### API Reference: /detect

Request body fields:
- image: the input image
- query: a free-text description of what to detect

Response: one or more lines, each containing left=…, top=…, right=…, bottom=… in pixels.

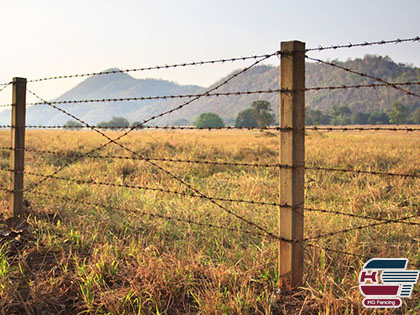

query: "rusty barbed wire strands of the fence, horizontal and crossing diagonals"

left=0, top=37, right=420, bottom=288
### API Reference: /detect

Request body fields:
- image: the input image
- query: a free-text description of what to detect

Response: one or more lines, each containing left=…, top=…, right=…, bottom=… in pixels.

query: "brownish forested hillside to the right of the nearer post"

left=306, top=55, right=420, bottom=112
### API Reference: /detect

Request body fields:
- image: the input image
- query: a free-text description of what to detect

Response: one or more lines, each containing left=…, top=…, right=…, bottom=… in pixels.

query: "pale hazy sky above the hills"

left=0, top=0, right=420, bottom=103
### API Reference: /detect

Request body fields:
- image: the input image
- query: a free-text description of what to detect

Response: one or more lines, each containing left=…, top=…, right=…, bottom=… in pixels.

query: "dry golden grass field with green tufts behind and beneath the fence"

left=0, top=130, right=420, bottom=314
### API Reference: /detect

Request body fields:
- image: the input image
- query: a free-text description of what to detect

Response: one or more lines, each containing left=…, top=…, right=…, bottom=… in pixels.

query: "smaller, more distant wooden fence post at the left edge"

left=9, top=78, right=26, bottom=217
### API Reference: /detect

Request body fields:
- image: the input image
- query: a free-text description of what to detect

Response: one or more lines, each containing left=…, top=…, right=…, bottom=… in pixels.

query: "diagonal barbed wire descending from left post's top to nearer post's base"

left=24, top=89, right=290, bottom=241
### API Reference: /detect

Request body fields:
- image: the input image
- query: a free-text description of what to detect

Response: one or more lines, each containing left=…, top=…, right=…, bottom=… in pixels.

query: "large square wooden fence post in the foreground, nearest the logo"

left=279, top=41, right=305, bottom=289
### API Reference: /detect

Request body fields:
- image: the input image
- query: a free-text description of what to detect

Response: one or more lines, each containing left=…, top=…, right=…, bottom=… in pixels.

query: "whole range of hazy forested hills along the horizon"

left=0, top=55, right=420, bottom=124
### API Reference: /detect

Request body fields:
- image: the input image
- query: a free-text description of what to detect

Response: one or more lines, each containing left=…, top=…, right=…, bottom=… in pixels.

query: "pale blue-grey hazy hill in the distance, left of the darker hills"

left=0, top=69, right=201, bottom=125
